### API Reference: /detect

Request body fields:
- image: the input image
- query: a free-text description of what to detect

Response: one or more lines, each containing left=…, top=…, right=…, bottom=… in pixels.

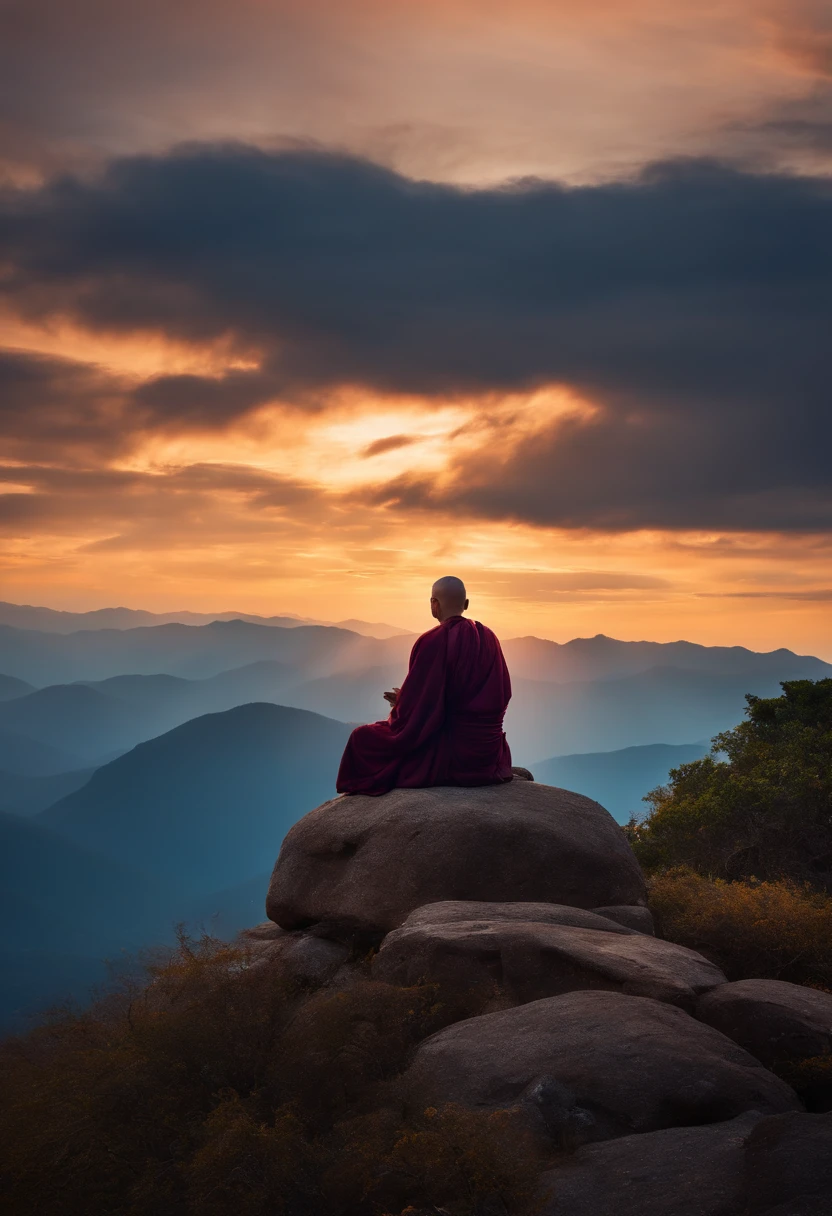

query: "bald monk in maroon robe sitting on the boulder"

left=336, top=576, right=512, bottom=794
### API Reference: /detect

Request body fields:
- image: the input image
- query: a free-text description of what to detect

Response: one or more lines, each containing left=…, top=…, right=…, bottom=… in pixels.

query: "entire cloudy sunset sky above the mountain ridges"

left=0, top=0, right=832, bottom=659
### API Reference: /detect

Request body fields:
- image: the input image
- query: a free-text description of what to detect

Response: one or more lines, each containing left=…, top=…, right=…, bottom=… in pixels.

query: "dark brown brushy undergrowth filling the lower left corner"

left=0, top=938, right=540, bottom=1216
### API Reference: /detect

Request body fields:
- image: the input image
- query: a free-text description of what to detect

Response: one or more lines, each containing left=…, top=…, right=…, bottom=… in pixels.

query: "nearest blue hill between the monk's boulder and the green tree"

left=532, top=743, right=710, bottom=823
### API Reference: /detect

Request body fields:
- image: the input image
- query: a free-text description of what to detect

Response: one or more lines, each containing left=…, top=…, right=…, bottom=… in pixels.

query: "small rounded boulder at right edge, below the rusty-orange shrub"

left=696, top=980, right=832, bottom=1065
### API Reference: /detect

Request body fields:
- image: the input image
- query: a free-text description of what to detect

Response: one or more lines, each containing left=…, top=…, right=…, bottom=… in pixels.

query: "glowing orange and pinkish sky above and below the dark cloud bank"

left=0, top=0, right=832, bottom=659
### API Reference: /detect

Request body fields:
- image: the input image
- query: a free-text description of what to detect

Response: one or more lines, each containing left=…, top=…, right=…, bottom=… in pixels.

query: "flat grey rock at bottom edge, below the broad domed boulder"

left=541, top=1113, right=760, bottom=1216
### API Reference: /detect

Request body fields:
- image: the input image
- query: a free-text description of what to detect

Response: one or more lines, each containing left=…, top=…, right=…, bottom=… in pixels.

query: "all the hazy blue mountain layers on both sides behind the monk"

left=0, top=604, right=832, bottom=1025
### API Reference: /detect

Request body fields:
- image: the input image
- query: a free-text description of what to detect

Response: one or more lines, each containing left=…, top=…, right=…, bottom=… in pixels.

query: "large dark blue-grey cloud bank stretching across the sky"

left=0, top=139, right=832, bottom=529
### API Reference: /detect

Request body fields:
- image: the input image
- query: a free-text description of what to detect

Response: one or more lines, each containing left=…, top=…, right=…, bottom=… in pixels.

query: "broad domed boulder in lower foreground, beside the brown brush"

left=404, top=987, right=800, bottom=1141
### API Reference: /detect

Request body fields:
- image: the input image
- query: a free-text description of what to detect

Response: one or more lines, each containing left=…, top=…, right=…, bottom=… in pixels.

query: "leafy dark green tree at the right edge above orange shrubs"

left=626, top=680, right=832, bottom=890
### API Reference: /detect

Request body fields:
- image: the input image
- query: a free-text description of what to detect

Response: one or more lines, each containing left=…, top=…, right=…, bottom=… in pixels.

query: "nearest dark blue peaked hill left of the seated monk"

left=39, top=704, right=349, bottom=899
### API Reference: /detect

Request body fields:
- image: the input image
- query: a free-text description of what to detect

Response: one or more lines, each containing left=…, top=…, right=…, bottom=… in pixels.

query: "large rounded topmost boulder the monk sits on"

left=266, top=781, right=646, bottom=936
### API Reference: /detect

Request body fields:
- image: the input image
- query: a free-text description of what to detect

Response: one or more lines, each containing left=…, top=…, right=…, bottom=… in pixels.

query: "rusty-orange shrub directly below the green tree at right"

left=650, top=869, right=832, bottom=989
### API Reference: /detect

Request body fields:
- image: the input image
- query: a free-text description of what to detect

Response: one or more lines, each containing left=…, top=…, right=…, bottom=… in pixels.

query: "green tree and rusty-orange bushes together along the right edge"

left=625, top=680, right=832, bottom=989
